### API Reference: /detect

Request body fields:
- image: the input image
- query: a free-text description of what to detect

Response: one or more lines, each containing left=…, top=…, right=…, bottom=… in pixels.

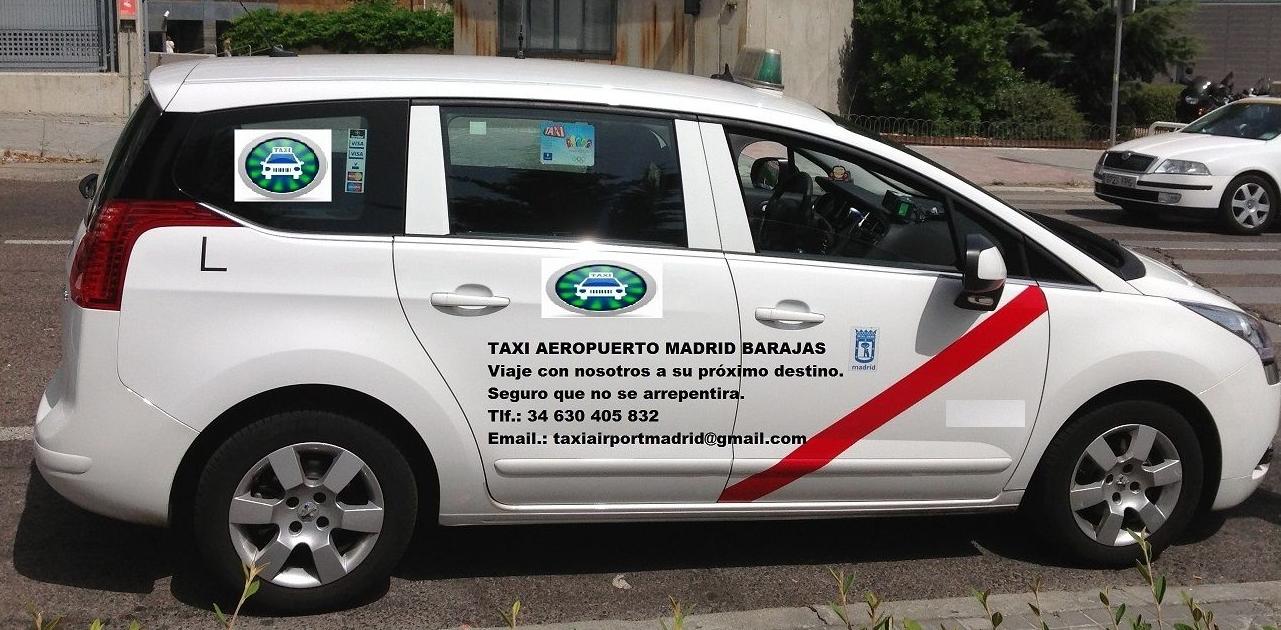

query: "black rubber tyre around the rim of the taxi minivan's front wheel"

left=1022, top=401, right=1204, bottom=567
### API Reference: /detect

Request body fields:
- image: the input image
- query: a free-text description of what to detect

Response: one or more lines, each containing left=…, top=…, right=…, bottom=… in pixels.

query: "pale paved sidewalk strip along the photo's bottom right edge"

left=471, top=581, right=1281, bottom=630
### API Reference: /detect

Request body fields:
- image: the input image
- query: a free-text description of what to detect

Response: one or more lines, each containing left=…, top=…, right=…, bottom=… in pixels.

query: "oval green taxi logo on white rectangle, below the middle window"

left=542, top=259, right=662, bottom=318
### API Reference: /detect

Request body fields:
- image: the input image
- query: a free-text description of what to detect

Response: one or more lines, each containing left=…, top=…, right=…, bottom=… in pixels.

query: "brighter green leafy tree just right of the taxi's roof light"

left=844, top=0, right=1018, bottom=120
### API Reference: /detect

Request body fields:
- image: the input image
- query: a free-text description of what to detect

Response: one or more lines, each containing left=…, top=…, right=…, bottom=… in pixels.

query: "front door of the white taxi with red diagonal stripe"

left=705, top=125, right=1049, bottom=503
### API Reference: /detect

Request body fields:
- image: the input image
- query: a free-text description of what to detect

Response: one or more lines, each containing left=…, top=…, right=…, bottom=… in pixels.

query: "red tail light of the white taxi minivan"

left=68, top=200, right=237, bottom=311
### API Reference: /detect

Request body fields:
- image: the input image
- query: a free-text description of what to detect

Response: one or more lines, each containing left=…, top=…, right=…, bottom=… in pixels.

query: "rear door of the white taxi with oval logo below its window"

left=395, top=105, right=739, bottom=505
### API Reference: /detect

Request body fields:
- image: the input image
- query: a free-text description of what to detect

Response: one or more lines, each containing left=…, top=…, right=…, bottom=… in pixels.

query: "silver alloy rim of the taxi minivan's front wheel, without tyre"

left=1067, top=424, right=1184, bottom=547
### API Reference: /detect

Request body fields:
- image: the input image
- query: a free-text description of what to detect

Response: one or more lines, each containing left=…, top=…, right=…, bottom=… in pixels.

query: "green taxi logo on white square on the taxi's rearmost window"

left=233, top=129, right=333, bottom=202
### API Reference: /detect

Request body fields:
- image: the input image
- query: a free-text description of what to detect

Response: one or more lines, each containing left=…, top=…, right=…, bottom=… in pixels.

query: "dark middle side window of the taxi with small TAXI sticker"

left=443, top=108, right=687, bottom=246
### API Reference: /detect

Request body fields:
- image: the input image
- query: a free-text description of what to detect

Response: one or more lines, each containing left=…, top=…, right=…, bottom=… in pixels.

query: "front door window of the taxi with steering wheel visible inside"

left=729, top=133, right=958, bottom=269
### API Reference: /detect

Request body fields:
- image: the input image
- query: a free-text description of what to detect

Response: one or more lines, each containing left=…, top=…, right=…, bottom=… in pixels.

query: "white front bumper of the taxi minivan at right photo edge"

left=1200, top=362, right=1281, bottom=510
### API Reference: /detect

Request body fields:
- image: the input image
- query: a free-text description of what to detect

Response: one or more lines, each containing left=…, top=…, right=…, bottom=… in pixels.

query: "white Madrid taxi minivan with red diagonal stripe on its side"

left=35, top=55, right=1281, bottom=611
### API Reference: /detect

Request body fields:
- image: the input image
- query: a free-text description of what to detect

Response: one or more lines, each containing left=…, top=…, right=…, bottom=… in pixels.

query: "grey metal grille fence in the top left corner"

left=0, top=0, right=115, bottom=72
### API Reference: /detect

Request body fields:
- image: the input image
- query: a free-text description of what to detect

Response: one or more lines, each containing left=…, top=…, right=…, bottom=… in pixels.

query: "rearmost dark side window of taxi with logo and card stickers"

left=174, top=101, right=409, bottom=234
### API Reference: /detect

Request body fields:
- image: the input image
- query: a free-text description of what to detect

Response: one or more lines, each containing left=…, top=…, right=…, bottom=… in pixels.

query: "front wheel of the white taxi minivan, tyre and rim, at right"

left=1025, top=401, right=1204, bottom=566
